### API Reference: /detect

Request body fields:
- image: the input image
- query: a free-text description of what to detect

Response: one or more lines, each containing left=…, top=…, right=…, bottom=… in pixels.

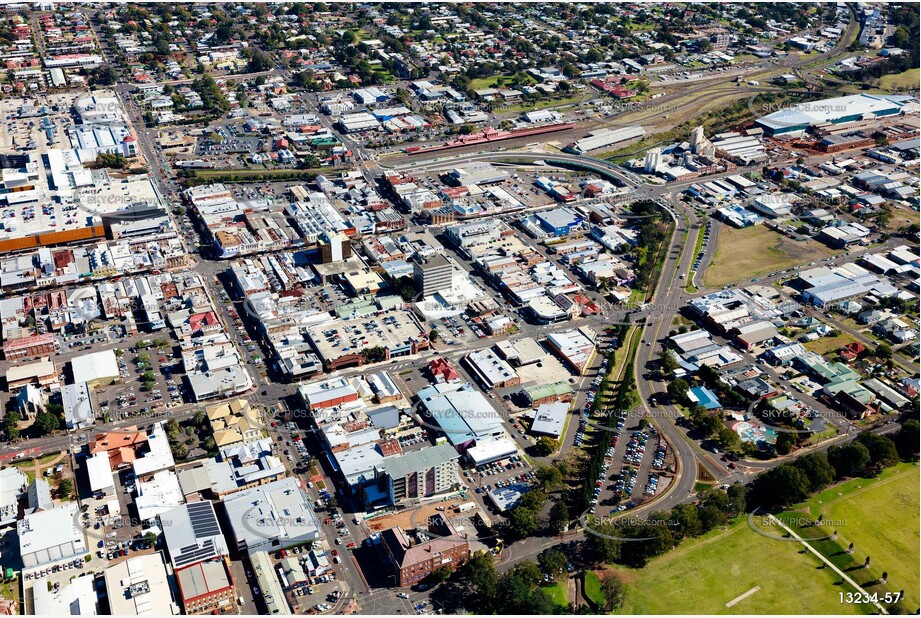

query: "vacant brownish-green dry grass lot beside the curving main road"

left=703, top=225, right=837, bottom=288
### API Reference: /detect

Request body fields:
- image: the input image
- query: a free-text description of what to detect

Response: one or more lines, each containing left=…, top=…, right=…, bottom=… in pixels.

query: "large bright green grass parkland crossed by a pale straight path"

left=604, top=464, right=921, bottom=614
